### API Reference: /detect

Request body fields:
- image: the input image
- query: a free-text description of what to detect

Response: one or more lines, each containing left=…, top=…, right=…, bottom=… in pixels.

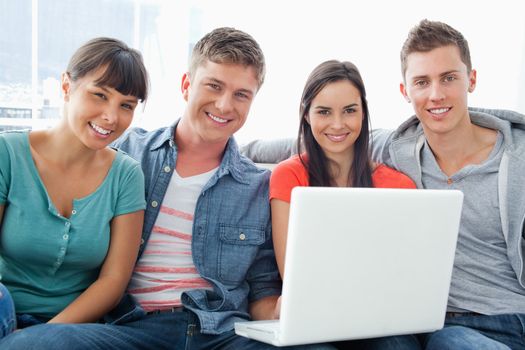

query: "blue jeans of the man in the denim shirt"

left=0, top=311, right=334, bottom=350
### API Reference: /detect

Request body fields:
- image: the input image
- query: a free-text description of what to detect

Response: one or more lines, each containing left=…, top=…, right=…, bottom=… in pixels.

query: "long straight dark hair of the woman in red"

left=297, top=60, right=373, bottom=187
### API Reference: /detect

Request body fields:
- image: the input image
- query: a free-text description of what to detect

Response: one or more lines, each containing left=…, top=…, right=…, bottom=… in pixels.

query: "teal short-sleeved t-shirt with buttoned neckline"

left=0, top=131, right=146, bottom=318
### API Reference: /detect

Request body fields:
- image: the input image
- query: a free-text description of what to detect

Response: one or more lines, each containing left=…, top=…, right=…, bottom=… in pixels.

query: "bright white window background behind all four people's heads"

left=0, top=0, right=525, bottom=142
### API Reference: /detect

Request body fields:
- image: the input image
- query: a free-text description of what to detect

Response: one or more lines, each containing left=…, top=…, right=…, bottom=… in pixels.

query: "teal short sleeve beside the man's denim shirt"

left=115, top=156, right=146, bottom=216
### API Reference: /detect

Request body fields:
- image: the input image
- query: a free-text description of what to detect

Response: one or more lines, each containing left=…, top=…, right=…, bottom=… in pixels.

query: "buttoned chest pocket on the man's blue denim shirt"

left=218, top=223, right=265, bottom=283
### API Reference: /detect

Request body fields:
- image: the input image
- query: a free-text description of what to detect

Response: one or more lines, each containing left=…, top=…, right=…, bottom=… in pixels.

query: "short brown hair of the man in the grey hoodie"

left=401, top=19, right=472, bottom=79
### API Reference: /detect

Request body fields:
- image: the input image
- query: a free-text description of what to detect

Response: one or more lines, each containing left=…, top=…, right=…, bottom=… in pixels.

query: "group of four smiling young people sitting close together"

left=0, top=20, right=525, bottom=349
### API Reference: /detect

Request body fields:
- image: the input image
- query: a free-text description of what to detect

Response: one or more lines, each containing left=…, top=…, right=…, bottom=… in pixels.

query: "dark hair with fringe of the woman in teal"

left=67, top=37, right=148, bottom=102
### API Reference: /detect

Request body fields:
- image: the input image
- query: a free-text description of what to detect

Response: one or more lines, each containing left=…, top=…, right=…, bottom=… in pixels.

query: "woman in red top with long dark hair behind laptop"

left=270, top=60, right=416, bottom=276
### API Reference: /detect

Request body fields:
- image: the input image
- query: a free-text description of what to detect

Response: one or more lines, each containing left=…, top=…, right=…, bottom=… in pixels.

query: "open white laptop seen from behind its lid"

left=235, top=187, right=463, bottom=346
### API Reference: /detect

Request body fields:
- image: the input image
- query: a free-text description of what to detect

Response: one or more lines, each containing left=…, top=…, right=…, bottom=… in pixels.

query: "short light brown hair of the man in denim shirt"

left=189, top=27, right=266, bottom=88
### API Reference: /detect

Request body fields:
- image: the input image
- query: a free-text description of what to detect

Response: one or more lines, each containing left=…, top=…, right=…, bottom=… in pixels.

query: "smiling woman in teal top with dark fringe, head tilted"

left=0, top=38, right=148, bottom=336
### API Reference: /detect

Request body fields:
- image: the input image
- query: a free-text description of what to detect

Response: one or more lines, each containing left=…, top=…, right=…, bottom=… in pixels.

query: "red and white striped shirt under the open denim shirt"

left=128, top=168, right=217, bottom=311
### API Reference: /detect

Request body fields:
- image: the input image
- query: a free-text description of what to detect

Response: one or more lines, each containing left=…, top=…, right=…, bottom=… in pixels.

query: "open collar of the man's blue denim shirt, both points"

left=150, top=119, right=250, bottom=184
